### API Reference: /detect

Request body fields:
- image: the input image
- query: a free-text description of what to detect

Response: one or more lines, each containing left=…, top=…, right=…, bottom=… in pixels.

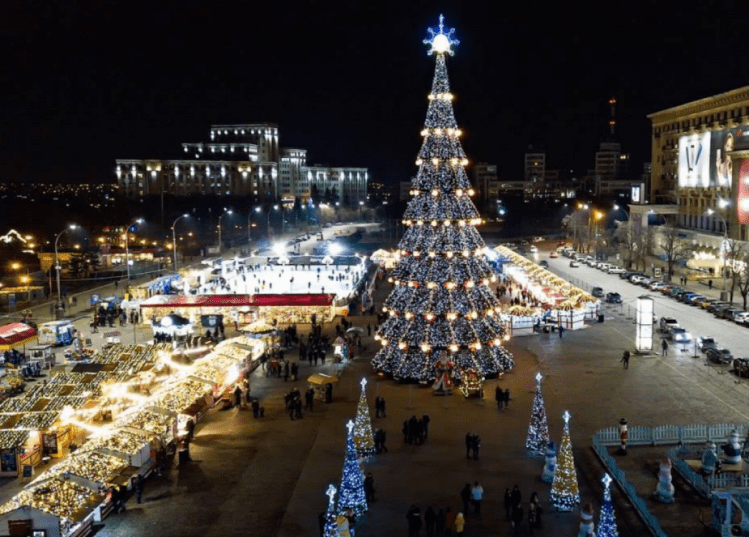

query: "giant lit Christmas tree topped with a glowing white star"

left=372, top=16, right=514, bottom=381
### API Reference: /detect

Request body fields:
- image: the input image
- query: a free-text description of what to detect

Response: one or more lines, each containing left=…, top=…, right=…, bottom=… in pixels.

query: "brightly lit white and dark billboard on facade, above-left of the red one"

left=679, top=127, right=749, bottom=188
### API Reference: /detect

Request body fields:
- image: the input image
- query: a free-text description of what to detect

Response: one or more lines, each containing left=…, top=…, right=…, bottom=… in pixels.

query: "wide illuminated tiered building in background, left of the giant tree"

left=115, top=123, right=369, bottom=206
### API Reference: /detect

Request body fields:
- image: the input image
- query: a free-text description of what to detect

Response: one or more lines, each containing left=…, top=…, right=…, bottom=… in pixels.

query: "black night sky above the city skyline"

left=0, top=0, right=749, bottom=187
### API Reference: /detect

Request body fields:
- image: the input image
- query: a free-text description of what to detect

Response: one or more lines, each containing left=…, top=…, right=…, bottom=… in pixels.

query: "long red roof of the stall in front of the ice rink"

left=141, top=294, right=335, bottom=308
